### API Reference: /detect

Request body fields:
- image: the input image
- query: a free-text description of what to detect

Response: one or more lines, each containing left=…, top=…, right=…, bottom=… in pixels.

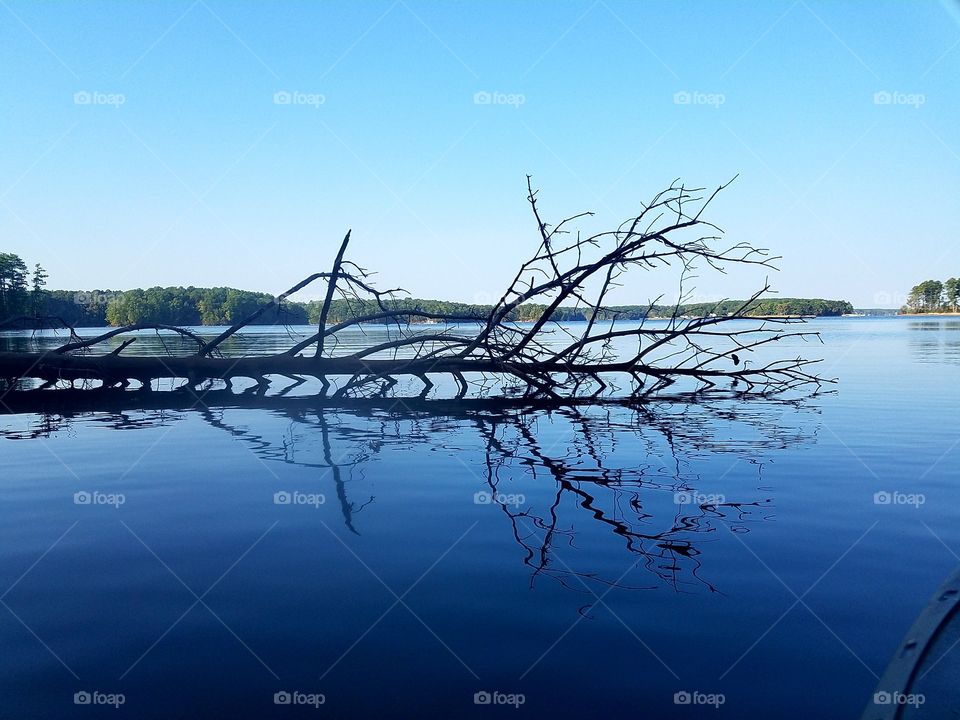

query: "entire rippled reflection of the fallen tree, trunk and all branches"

left=0, top=399, right=819, bottom=596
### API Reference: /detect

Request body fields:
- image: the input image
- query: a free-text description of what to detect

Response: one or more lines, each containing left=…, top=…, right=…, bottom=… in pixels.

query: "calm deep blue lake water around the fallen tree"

left=0, top=318, right=960, bottom=718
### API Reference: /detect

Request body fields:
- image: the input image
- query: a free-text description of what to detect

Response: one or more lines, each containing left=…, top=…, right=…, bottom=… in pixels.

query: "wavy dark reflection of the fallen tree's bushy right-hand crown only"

left=475, top=405, right=803, bottom=594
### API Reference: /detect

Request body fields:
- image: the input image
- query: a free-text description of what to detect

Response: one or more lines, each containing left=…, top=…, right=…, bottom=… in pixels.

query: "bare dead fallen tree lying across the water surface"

left=0, top=178, right=829, bottom=403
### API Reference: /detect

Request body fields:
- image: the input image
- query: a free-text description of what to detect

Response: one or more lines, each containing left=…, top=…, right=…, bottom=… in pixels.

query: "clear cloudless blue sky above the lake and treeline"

left=0, top=0, right=960, bottom=307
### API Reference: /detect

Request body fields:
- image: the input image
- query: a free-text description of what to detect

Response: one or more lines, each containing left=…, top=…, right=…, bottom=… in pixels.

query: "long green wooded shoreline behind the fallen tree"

left=0, top=248, right=854, bottom=327
